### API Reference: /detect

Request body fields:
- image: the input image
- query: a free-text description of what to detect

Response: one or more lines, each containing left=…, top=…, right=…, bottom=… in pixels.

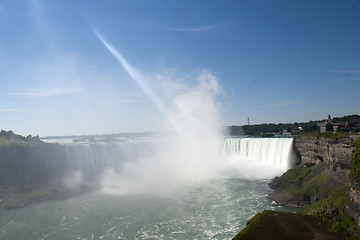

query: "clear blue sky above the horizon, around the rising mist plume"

left=0, top=0, right=360, bottom=136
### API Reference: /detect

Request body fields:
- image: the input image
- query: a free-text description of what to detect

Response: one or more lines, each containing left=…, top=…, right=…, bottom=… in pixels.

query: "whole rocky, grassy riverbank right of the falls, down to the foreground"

left=235, top=137, right=360, bottom=239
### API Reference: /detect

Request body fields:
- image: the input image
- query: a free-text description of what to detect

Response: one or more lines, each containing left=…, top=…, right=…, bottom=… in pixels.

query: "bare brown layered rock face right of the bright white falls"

left=294, top=137, right=354, bottom=174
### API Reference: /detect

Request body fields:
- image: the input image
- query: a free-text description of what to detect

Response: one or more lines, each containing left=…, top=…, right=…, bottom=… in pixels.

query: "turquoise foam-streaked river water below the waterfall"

left=0, top=179, right=271, bottom=240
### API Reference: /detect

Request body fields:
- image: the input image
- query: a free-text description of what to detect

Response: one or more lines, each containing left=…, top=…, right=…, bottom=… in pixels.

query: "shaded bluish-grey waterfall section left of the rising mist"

left=64, top=138, right=159, bottom=187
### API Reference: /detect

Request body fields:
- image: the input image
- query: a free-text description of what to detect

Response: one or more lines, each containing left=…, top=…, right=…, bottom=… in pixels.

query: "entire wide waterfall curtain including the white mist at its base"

left=59, top=138, right=293, bottom=188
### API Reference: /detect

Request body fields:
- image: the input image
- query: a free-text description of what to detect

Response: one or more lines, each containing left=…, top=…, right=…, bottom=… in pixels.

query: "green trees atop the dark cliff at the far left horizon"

left=0, top=130, right=43, bottom=146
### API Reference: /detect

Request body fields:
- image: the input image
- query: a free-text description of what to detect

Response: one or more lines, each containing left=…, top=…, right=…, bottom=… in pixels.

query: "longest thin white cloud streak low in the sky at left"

left=10, top=88, right=84, bottom=97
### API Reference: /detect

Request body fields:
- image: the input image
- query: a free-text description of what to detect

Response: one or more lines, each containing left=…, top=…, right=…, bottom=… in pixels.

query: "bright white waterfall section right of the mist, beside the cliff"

left=223, top=138, right=293, bottom=179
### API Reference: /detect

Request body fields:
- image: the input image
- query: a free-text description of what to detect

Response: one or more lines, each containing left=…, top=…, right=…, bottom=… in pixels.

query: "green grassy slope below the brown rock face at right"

left=270, top=162, right=360, bottom=240
